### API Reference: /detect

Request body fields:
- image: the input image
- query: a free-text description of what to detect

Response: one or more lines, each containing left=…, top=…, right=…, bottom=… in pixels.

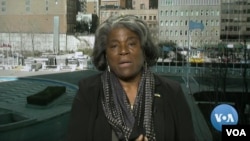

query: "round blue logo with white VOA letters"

left=210, top=104, right=238, bottom=131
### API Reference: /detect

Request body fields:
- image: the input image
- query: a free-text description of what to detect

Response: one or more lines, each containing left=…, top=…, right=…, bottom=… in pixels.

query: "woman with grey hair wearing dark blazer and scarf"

left=68, top=15, right=194, bottom=141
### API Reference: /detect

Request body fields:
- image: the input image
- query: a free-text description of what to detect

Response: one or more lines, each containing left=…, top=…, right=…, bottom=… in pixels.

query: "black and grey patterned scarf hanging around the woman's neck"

left=102, top=69, right=155, bottom=141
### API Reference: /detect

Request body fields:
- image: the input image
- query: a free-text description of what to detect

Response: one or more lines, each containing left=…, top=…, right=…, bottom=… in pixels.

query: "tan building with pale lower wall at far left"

left=0, top=0, right=77, bottom=53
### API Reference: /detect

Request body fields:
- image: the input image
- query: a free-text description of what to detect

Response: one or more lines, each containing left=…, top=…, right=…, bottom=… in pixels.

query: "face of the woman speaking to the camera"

left=106, top=27, right=144, bottom=79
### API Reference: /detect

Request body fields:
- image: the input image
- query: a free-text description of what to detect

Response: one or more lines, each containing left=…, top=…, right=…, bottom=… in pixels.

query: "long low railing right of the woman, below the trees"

left=151, top=62, right=250, bottom=78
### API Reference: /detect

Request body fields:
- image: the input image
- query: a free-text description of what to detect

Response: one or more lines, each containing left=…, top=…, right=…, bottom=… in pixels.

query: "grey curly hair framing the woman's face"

left=92, top=15, right=159, bottom=71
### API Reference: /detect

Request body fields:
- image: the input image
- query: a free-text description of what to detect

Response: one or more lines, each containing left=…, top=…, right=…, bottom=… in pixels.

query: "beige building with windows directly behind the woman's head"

left=99, top=0, right=158, bottom=41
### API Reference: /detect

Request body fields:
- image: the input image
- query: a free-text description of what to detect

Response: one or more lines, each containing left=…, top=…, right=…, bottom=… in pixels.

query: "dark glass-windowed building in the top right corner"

left=220, top=0, right=250, bottom=43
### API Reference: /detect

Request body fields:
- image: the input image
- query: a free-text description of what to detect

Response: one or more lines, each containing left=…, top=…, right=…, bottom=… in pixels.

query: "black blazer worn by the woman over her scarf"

left=67, top=74, right=195, bottom=141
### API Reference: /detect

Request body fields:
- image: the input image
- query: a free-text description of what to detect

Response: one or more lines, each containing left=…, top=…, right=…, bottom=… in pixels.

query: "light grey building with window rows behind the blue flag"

left=158, top=0, right=221, bottom=47
